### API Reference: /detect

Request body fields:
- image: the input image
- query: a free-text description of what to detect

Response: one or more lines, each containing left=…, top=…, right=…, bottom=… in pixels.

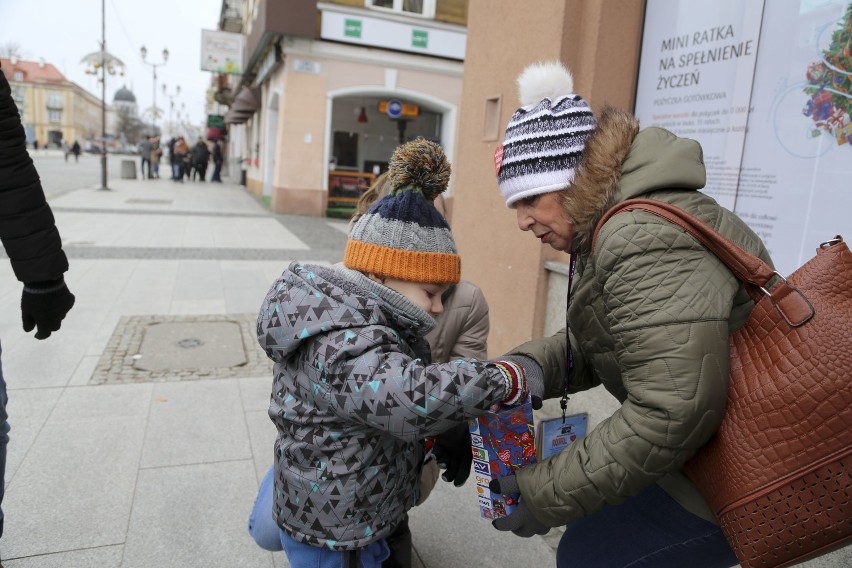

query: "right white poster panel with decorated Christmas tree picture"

left=734, top=0, right=852, bottom=274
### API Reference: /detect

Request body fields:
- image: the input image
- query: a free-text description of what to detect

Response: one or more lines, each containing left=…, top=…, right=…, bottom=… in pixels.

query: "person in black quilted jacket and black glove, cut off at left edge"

left=0, top=62, right=74, bottom=552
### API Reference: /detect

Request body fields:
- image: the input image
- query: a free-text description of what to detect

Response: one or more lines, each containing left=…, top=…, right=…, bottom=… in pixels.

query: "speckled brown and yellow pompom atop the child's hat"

left=388, top=138, right=450, bottom=202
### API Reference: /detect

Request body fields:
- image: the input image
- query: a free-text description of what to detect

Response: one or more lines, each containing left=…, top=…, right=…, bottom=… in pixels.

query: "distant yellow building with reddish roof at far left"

left=0, top=57, right=106, bottom=147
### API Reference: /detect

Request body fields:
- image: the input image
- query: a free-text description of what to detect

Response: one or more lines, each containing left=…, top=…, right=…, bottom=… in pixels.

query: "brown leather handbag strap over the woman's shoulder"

left=592, top=198, right=815, bottom=327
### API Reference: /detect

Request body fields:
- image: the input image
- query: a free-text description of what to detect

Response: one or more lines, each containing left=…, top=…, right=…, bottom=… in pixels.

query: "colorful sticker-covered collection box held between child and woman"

left=469, top=398, right=536, bottom=519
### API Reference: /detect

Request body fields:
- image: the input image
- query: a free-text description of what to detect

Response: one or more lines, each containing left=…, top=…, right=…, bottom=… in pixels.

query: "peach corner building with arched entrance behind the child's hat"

left=216, top=0, right=467, bottom=216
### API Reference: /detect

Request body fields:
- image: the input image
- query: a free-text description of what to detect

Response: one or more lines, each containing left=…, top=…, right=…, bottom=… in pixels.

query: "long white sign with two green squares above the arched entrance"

left=320, top=4, right=467, bottom=60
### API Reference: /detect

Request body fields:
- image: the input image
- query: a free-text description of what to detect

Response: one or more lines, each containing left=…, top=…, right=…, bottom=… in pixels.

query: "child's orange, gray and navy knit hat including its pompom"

left=343, top=138, right=461, bottom=284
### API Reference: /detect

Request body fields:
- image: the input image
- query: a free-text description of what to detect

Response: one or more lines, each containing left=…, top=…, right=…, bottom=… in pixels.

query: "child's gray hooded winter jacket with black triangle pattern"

left=257, top=263, right=507, bottom=550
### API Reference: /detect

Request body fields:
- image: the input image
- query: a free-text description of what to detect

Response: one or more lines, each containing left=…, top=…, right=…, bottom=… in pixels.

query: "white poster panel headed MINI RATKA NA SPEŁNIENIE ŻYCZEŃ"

left=636, top=0, right=763, bottom=209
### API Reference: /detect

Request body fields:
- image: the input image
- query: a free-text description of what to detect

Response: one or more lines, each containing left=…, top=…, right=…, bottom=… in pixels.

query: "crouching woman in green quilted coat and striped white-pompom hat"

left=486, top=62, right=771, bottom=568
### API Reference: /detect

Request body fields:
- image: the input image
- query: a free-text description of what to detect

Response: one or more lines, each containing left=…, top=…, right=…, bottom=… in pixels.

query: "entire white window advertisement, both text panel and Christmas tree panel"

left=636, top=0, right=852, bottom=274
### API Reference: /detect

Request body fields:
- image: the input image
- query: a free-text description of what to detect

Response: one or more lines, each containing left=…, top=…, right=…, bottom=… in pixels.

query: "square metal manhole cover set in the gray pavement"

left=133, top=321, right=246, bottom=371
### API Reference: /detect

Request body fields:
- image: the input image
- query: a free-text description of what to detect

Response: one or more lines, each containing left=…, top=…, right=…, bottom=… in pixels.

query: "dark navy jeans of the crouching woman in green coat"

left=556, top=485, right=739, bottom=568
